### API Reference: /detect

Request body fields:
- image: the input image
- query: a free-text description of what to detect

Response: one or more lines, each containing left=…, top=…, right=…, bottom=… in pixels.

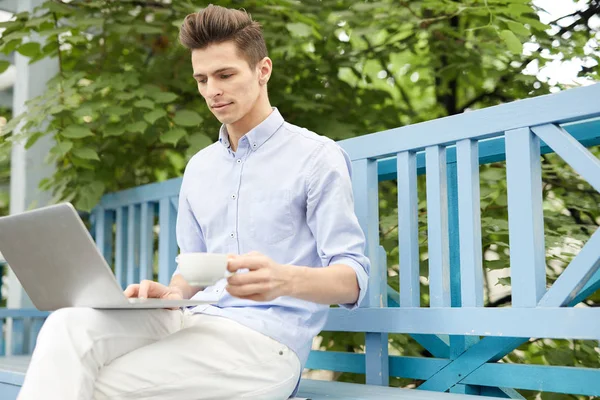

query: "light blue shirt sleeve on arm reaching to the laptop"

left=173, top=166, right=207, bottom=275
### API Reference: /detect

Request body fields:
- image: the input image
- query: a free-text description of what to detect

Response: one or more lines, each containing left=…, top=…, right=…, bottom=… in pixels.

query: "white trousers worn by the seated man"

left=18, top=308, right=301, bottom=400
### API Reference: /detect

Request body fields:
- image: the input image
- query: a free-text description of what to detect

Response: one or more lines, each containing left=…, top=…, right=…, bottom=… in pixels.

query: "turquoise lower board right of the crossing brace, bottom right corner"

left=463, top=363, right=600, bottom=396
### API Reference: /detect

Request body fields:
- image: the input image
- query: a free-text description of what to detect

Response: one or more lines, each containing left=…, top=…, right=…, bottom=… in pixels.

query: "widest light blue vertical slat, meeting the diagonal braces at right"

left=506, top=128, right=546, bottom=307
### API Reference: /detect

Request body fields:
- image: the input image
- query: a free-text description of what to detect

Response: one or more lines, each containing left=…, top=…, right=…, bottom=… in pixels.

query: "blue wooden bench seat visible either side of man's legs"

left=0, top=356, right=493, bottom=400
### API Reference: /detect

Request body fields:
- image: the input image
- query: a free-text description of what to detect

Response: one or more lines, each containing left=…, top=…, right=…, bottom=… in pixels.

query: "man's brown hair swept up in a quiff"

left=179, top=4, right=268, bottom=67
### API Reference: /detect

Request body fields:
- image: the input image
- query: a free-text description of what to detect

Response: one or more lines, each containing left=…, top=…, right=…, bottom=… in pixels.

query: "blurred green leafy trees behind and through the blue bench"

left=0, top=0, right=600, bottom=399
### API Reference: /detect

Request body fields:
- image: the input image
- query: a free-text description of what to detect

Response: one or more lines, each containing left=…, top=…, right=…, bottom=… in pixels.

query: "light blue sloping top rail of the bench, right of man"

left=339, top=84, right=600, bottom=160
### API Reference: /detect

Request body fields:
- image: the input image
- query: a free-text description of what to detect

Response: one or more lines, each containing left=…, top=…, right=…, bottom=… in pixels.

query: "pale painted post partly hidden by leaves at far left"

left=6, top=0, right=59, bottom=353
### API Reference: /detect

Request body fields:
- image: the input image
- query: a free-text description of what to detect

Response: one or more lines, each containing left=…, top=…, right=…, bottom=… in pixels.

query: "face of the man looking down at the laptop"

left=192, top=42, right=261, bottom=125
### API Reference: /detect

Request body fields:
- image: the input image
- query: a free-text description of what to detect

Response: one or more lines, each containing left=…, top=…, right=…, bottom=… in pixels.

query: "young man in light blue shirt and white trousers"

left=19, top=6, right=369, bottom=400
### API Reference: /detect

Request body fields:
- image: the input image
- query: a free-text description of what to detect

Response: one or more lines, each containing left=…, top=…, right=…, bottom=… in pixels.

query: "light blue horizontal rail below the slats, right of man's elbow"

left=324, top=307, right=600, bottom=340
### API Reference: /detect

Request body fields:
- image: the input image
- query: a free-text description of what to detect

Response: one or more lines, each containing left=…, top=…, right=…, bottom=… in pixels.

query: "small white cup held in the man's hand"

left=175, top=253, right=231, bottom=287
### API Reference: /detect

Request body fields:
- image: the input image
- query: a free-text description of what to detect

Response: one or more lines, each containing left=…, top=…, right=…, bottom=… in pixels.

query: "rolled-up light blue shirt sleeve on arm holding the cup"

left=307, top=142, right=370, bottom=310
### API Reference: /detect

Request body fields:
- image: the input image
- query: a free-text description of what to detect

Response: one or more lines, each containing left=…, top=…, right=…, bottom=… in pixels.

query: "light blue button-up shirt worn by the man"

left=176, top=109, right=370, bottom=384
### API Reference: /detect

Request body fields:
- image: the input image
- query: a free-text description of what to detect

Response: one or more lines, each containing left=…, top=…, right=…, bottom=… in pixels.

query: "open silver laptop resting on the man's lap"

left=0, top=203, right=216, bottom=311
